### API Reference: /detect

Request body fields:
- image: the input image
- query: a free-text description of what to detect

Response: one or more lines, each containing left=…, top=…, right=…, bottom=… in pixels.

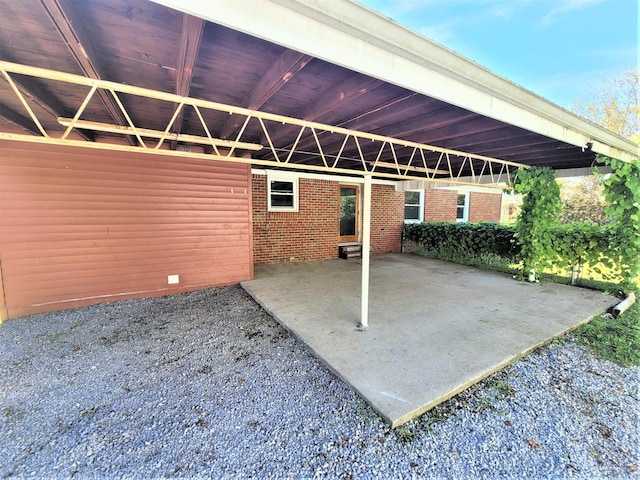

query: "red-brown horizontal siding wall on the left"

left=0, top=142, right=253, bottom=318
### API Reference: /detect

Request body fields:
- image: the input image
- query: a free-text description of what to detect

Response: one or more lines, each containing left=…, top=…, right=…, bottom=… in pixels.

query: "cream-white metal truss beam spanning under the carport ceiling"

left=0, top=61, right=526, bottom=188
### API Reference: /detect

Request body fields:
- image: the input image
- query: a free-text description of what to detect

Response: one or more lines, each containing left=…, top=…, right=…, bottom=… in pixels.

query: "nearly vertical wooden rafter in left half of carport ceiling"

left=171, top=13, right=204, bottom=150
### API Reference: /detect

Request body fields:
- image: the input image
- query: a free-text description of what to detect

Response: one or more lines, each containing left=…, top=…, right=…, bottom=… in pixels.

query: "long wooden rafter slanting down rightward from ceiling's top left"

left=41, top=0, right=135, bottom=145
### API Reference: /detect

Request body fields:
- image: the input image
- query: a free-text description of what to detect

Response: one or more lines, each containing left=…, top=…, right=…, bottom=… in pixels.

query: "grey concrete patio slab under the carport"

left=242, top=254, right=617, bottom=427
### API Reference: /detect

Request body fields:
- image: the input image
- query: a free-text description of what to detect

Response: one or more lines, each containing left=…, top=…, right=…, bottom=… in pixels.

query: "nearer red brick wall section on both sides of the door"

left=252, top=175, right=404, bottom=265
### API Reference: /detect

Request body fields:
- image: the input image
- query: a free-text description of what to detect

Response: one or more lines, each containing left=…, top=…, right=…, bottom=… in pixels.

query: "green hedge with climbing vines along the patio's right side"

left=404, top=158, right=640, bottom=292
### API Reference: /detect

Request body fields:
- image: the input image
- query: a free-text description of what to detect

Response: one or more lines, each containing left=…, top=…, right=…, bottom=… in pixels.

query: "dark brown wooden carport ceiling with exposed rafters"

left=0, top=0, right=632, bottom=176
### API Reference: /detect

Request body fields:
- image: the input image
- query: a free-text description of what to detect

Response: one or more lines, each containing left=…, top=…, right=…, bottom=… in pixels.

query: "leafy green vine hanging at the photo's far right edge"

left=598, top=157, right=640, bottom=290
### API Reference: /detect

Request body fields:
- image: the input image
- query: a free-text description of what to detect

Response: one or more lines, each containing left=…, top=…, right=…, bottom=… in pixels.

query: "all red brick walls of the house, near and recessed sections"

left=251, top=173, right=502, bottom=265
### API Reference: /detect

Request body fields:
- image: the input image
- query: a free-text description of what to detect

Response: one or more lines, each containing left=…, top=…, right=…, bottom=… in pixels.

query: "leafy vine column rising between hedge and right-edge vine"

left=513, top=167, right=562, bottom=279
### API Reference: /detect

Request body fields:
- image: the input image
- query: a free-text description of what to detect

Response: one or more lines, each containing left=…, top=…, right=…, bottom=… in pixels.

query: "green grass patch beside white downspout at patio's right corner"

left=574, top=301, right=640, bottom=367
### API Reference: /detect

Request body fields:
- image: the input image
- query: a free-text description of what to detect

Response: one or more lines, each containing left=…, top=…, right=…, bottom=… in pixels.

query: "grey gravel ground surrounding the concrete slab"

left=0, top=287, right=640, bottom=479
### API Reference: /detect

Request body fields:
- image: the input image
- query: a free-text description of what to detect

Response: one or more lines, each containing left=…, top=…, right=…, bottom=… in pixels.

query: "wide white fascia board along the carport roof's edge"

left=154, top=0, right=640, bottom=161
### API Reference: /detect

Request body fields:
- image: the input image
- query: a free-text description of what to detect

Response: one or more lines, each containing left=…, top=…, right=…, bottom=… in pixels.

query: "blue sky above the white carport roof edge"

left=360, top=0, right=638, bottom=108
